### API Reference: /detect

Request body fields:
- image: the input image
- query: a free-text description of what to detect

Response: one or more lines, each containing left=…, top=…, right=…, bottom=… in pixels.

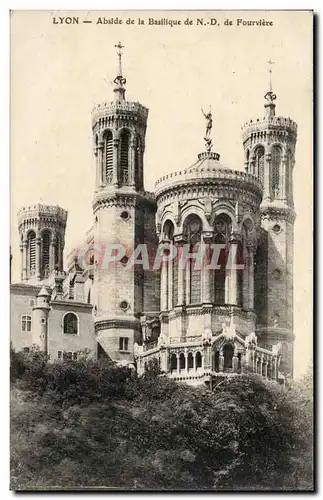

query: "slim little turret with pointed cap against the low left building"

left=32, top=285, right=50, bottom=352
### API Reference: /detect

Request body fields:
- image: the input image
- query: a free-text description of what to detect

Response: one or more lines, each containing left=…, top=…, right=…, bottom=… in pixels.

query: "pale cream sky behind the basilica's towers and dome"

left=10, top=11, right=313, bottom=376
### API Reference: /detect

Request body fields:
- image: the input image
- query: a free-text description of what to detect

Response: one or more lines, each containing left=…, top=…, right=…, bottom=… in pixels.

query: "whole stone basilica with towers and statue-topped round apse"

left=11, top=43, right=297, bottom=385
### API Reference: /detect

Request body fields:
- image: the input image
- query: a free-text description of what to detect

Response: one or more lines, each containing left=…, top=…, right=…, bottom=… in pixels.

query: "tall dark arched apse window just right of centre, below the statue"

left=214, top=214, right=231, bottom=305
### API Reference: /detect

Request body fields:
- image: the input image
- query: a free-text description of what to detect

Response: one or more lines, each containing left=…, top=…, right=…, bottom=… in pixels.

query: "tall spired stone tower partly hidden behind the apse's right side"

left=243, top=71, right=297, bottom=374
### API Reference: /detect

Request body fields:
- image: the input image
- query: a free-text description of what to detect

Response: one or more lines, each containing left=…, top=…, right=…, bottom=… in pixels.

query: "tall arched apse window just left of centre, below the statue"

left=184, top=215, right=202, bottom=304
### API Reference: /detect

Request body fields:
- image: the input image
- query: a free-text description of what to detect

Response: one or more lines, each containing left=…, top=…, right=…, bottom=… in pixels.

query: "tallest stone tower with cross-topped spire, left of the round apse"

left=92, top=42, right=158, bottom=362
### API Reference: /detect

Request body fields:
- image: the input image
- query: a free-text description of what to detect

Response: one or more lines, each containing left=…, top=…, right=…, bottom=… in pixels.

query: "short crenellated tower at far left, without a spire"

left=18, top=203, right=67, bottom=282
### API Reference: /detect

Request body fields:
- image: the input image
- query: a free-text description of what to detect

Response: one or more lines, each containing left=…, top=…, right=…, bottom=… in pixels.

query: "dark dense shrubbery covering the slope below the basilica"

left=11, top=350, right=312, bottom=490
